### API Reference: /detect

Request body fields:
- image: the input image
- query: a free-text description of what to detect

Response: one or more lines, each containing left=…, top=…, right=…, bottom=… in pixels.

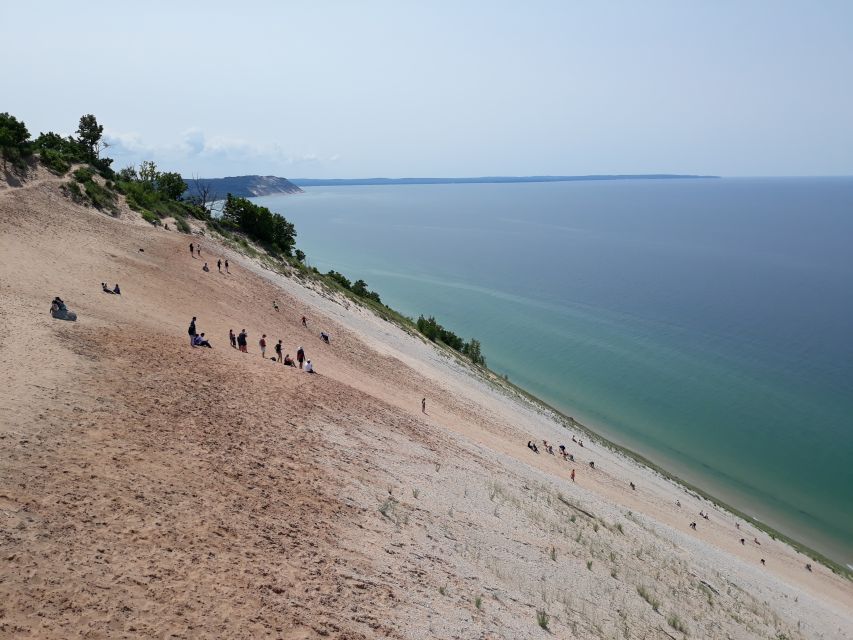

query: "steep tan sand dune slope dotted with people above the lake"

left=0, top=172, right=853, bottom=639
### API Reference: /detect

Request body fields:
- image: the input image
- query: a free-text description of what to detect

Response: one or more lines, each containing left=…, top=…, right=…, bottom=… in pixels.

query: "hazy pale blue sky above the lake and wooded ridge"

left=0, top=0, right=853, bottom=178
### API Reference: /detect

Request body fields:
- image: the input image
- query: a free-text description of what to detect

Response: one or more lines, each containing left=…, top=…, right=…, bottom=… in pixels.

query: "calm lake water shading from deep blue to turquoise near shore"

left=256, top=178, right=853, bottom=563
